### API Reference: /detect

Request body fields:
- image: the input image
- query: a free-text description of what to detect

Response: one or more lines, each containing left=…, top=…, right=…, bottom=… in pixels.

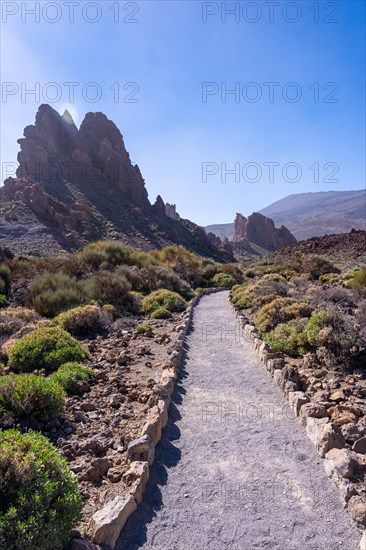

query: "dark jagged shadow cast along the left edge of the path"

left=116, top=345, right=192, bottom=550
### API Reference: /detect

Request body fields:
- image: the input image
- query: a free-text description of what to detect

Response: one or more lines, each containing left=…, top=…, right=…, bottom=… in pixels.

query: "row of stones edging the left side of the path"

left=70, top=288, right=219, bottom=550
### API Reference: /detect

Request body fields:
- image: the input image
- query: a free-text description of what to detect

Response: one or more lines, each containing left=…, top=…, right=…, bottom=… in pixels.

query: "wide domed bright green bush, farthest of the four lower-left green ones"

left=9, top=327, right=89, bottom=372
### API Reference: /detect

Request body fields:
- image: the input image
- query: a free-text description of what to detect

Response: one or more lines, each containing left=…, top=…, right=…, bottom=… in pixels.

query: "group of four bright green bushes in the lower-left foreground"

left=0, top=326, right=93, bottom=550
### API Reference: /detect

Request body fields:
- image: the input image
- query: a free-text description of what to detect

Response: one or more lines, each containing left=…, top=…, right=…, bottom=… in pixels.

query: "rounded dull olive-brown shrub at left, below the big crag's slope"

left=30, top=272, right=85, bottom=317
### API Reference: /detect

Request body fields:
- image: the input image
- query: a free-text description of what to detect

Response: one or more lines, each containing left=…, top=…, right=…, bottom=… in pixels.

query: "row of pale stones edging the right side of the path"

left=233, top=306, right=366, bottom=550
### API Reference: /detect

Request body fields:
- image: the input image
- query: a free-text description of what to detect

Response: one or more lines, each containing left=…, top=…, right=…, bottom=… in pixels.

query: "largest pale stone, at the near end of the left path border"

left=91, top=495, right=137, bottom=550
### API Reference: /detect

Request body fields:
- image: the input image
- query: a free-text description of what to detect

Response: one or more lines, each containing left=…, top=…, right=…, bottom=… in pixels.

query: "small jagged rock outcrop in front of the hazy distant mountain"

left=233, top=212, right=297, bottom=251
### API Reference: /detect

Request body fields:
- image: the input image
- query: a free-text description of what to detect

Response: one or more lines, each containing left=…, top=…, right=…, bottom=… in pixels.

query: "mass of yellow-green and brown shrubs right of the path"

left=231, top=254, right=366, bottom=367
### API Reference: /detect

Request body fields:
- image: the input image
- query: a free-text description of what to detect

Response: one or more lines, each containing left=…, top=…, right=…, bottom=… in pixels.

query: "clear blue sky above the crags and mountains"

left=1, top=0, right=366, bottom=225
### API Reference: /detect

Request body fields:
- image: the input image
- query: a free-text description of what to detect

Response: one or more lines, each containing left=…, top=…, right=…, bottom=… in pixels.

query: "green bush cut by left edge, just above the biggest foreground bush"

left=0, top=374, right=65, bottom=424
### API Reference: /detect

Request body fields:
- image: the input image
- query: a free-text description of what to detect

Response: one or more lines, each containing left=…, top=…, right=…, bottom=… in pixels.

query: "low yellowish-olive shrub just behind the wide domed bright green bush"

left=53, top=305, right=112, bottom=336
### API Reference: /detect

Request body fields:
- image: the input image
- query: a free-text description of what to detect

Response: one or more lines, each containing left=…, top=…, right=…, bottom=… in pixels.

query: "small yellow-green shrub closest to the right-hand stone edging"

left=265, top=318, right=307, bottom=357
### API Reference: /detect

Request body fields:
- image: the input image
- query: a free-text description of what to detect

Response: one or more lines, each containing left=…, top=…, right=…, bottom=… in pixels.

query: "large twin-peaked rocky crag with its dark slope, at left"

left=0, top=105, right=231, bottom=261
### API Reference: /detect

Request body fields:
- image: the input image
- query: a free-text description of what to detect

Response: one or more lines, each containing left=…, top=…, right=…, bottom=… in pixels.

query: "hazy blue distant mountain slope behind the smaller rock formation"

left=205, top=189, right=366, bottom=240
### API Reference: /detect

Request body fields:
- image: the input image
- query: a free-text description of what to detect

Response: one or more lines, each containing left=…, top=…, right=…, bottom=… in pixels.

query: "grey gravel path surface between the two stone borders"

left=116, top=292, right=360, bottom=550
